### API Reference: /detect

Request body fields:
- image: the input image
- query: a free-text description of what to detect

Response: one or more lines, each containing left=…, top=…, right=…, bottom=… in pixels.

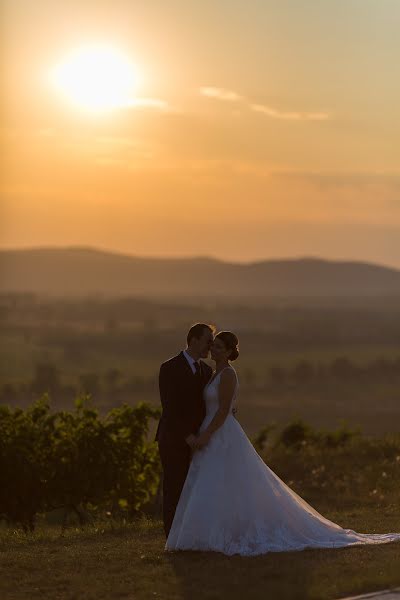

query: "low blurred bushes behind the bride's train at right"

left=256, top=420, right=400, bottom=508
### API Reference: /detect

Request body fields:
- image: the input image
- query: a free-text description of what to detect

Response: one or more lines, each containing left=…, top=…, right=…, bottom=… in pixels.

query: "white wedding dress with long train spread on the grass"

left=165, top=367, right=400, bottom=556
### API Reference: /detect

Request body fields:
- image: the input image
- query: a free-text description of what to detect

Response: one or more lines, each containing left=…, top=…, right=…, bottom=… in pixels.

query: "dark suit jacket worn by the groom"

left=155, top=352, right=212, bottom=444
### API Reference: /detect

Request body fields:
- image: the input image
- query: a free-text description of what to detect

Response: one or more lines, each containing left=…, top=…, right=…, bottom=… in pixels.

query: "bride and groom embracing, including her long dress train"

left=156, top=323, right=400, bottom=556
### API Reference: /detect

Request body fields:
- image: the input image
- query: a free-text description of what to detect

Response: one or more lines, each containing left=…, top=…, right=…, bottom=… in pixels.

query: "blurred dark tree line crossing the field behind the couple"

left=0, top=356, right=400, bottom=404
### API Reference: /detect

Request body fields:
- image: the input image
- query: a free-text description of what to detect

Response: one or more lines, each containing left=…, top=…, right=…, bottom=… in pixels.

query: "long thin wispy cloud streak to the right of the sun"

left=200, top=86, right=332, bottom=121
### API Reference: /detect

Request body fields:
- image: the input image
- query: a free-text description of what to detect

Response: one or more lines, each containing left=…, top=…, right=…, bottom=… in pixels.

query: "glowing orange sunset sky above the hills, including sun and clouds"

left=0, top=0, right=400, bottom=268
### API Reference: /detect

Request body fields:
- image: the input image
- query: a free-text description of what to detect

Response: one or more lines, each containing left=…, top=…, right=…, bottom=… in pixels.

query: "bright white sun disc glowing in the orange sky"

left=50, top=44, right=139, bottom=112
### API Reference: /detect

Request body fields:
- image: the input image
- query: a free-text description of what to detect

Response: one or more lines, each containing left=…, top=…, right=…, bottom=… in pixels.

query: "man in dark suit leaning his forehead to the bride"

left=155, top=323, right=214, bottom=537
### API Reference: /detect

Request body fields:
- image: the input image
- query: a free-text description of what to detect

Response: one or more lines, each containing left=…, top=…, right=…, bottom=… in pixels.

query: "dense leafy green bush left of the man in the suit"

left=0, top=396, right=160, bottom=530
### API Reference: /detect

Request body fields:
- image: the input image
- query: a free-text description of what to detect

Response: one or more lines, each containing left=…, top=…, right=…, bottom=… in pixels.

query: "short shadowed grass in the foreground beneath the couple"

left=0, top=506, right=400, bottom=600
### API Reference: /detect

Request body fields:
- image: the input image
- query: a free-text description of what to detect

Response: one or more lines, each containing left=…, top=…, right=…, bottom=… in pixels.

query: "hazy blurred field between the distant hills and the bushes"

left=0, top=294, right=400, bottom=436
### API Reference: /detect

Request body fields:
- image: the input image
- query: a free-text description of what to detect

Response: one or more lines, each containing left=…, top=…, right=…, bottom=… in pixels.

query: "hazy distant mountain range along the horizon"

left=0, top=247, right=400, bottom=298
